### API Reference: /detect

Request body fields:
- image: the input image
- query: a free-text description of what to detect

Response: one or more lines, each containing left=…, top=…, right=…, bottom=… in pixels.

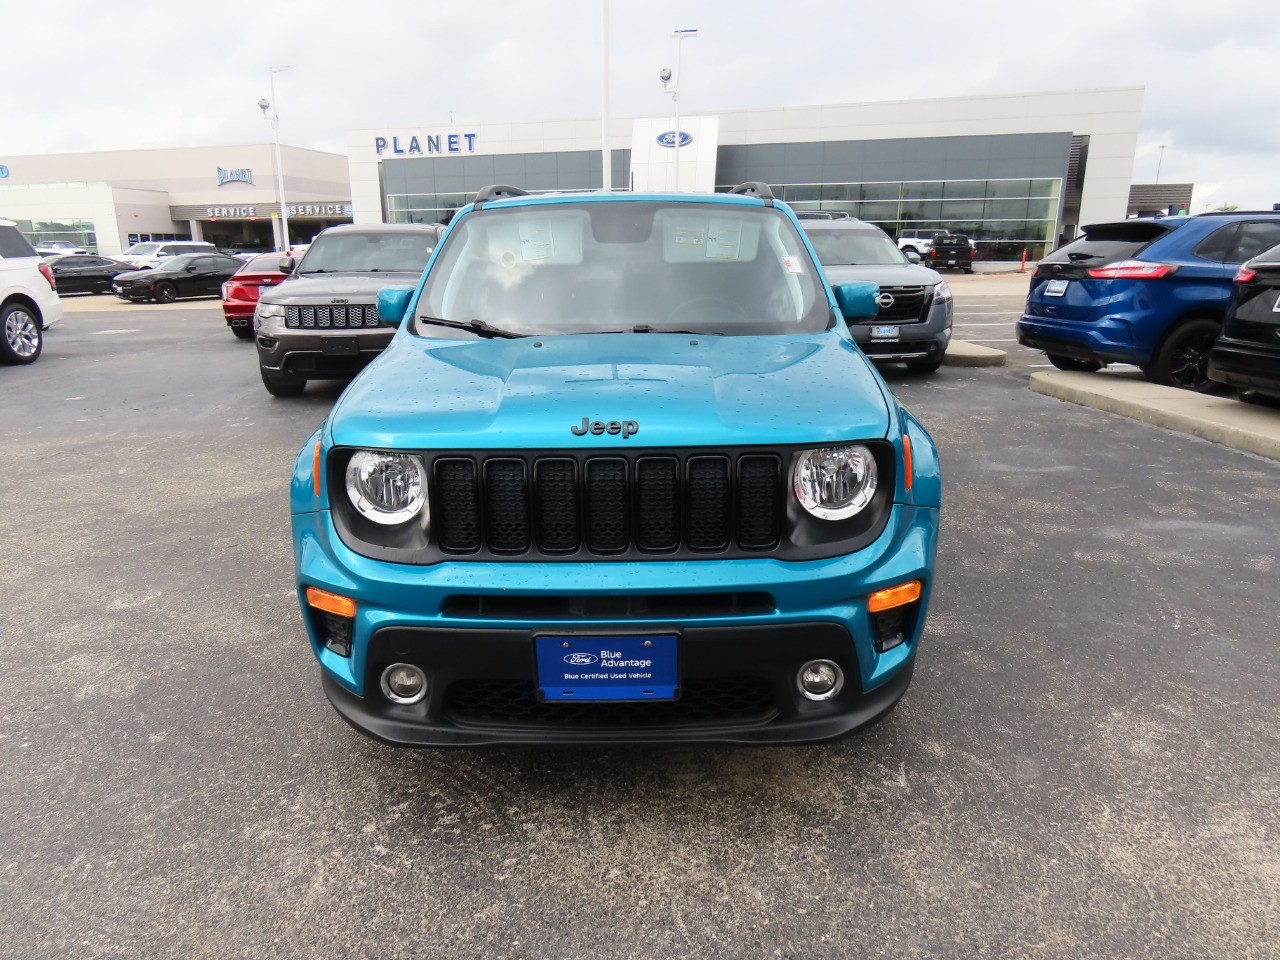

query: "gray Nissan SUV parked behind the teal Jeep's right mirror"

left=801, top=214, right=952, bottom=374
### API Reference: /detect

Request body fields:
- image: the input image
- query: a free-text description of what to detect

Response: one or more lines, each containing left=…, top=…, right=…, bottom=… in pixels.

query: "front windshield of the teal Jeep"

left=415, top=200, right=829, bottom=337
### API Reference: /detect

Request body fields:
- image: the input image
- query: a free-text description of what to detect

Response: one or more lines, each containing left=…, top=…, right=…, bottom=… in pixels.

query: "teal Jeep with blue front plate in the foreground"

left=292, top=184, right=941, bottom=746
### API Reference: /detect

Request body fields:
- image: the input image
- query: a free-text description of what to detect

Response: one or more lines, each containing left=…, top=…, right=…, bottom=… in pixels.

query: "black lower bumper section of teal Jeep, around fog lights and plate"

left=321, top=622, right=914, bottom=746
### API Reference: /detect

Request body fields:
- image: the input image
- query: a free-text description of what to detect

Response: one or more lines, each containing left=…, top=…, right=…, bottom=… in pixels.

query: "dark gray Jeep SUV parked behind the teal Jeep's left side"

left=253, top=224, right=444, bottom=397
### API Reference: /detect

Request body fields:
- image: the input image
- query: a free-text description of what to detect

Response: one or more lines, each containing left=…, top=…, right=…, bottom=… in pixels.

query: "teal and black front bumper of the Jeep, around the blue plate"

left=293, top=504, right=938, bottom=746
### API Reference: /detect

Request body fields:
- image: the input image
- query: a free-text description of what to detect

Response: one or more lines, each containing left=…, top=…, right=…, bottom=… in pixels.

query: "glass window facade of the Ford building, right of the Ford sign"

left=716, top=178, right=1062, bottom=260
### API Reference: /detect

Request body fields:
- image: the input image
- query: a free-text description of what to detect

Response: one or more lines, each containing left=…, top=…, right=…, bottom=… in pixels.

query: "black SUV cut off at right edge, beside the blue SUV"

left=1208, top=244, right=1280, bottom=399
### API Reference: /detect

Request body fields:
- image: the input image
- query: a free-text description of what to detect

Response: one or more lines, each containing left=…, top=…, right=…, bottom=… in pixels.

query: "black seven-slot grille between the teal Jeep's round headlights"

left=429, top=452, right=786, bottom=556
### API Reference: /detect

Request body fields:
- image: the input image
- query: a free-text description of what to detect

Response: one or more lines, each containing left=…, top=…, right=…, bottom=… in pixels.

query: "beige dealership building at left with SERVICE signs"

left=0, top=143, right=352, bottom=255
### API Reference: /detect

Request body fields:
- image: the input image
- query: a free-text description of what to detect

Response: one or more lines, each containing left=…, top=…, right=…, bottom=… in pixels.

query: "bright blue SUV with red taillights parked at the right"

left=1018, top=212, right=1280, bottom=390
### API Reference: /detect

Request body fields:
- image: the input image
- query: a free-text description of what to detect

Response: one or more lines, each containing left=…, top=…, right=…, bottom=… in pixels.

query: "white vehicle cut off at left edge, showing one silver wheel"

left=0, top=220, right=63, bottom=364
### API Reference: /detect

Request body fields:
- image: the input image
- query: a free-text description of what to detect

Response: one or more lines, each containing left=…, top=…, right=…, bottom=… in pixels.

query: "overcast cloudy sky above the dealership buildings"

left=0, top=0, right=1280, bottom=212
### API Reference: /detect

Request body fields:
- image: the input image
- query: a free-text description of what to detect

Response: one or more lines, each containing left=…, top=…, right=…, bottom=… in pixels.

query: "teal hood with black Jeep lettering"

left=330, top=330, right=888, bottom=449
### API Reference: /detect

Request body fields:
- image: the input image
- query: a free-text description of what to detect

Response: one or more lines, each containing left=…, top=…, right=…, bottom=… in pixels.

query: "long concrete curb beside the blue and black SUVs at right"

left=1030, top=370, right=1280, bottom=460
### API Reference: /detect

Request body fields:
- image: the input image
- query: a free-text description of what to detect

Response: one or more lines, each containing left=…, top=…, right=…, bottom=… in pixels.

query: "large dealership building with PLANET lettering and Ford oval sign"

left=347, top=87, right=1143, bottom=260
